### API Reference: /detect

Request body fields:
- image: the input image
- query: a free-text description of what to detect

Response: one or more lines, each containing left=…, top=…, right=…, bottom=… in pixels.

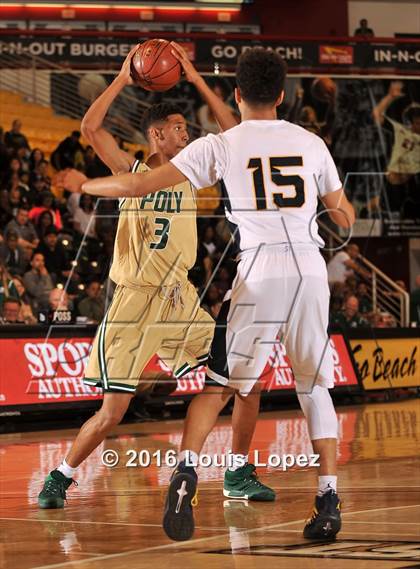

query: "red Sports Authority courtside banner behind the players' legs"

left=0, top=329, right=358, bottom=406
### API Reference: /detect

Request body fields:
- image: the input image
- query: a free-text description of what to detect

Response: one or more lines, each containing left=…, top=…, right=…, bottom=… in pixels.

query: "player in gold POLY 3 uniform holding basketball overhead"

left=38, top=46, right=272, bottom=508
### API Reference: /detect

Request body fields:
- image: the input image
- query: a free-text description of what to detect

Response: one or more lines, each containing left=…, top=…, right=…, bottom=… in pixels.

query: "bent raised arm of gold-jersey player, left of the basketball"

left=81, top=45, right=138, bottom=174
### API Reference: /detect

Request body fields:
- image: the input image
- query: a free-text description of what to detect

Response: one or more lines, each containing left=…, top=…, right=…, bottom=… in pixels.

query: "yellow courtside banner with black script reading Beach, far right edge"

left=350, top=329, right=420, bottom=391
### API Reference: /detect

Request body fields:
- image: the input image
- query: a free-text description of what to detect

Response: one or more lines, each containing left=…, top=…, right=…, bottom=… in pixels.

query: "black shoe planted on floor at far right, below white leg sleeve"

left=303, top=490, right=341, bottom=539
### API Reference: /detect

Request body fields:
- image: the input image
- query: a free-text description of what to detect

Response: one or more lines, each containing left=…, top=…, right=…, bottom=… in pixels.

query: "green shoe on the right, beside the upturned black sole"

left=223, top=463, right=276, bottom=502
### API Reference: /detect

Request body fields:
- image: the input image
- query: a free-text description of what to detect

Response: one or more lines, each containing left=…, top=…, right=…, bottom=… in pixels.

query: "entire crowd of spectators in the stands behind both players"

left=0, top=108, right=415, bottom=328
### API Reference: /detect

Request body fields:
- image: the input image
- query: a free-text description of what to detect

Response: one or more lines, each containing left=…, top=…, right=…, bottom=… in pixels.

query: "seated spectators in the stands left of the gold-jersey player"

left=0, top=120, right=117, bottom=324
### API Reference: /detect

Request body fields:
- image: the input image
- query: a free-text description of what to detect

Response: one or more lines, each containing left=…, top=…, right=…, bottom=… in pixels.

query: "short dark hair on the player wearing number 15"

left=236, top=47, right=287, bottom=106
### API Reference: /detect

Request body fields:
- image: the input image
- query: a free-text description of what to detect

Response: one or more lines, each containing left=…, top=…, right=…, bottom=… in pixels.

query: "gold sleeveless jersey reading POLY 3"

left=110, top=160, right=197, bottom=288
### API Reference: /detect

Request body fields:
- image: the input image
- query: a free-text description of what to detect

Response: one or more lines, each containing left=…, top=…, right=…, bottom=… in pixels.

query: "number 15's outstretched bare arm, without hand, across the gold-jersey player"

left=82, top=162, right=187, bottom=198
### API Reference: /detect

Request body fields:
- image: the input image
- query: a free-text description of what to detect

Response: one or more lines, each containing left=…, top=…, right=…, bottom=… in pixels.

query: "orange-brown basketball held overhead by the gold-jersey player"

left=131, top=39, right=181, bottom=91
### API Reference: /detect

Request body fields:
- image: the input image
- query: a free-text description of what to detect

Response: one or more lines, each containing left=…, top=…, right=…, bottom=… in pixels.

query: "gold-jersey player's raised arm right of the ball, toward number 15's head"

left=171, top=42, right=238, bottom=131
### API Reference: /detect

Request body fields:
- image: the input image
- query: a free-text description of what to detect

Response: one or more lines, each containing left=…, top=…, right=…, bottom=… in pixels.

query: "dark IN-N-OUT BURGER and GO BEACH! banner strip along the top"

left=0, top=34, right=420, bottom=75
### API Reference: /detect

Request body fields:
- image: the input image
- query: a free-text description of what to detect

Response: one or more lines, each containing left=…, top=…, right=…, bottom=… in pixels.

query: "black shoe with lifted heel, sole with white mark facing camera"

left=163, top=461, right=198, bottom=541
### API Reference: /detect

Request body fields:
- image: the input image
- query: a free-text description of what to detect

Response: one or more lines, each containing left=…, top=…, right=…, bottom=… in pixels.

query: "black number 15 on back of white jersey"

left=248, top=156, right=305, bottom=210
